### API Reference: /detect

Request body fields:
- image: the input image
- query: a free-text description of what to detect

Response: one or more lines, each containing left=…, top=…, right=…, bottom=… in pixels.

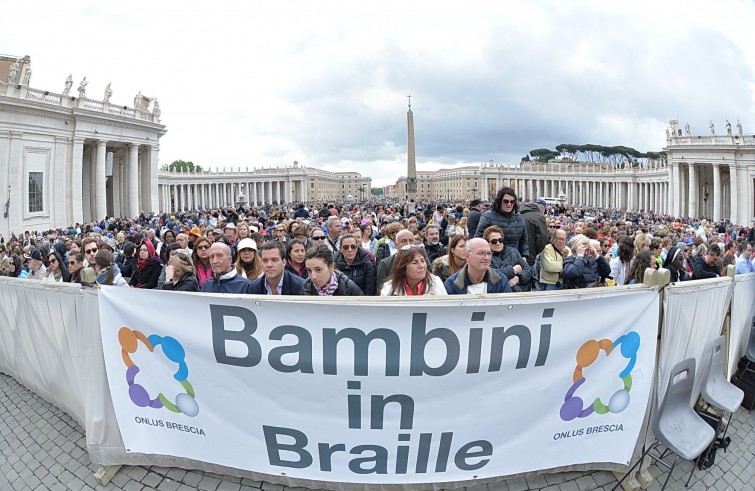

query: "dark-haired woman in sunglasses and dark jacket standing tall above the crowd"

left=474, top=187, right=530, bottom=260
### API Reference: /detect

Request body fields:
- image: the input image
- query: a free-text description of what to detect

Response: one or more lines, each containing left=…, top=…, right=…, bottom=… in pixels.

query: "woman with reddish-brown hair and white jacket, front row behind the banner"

left=380, top=246, right=448, bottom=297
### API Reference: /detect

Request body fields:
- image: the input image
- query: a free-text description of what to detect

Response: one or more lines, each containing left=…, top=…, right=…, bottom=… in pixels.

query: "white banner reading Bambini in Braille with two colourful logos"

left=99, top=288, right=658, bottom=483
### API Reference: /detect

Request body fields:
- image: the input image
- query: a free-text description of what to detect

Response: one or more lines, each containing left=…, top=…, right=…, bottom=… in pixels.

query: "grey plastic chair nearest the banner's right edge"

left=613, top=358, right=716, bottom=490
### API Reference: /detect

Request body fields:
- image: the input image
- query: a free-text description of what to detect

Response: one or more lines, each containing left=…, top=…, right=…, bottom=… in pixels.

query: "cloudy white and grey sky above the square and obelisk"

left=0, top=0, right=755, bottom=185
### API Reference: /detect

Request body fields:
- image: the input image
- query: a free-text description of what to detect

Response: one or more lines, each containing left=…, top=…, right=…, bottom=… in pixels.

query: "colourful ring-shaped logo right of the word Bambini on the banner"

left=560, top=331, right=640, bottom=421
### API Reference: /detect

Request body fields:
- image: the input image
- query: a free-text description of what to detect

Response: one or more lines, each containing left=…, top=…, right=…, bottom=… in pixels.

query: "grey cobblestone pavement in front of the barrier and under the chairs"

left=0, top=374, right=755, bottom=491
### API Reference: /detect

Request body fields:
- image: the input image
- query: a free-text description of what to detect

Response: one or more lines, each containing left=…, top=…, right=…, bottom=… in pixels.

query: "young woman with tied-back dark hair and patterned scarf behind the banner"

left=301, top=244, right=363, bottom=297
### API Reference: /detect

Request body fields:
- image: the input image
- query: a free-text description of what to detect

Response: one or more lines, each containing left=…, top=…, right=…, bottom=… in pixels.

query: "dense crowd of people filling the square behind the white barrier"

left=0, top=187, right=755, bottom=296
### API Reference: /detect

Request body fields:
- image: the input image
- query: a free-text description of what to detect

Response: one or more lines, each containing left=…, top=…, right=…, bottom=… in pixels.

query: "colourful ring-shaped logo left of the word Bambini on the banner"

left=118, top=327, right=199, bottom=417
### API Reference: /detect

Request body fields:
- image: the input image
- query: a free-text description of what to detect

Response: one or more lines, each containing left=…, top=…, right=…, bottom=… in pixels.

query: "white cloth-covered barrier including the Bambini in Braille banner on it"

left=0, top=275, right=755, bottom=489
